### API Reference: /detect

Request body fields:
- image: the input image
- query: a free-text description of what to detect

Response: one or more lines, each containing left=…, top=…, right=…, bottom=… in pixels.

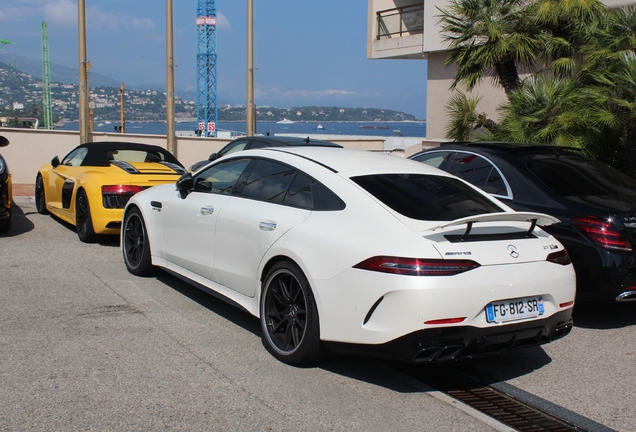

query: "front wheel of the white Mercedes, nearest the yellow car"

left=122, top=208, right=156, bottom=276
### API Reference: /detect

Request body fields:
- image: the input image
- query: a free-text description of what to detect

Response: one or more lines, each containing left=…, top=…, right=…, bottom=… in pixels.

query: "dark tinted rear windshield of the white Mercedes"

left=351, top=174, right=503, bottom=221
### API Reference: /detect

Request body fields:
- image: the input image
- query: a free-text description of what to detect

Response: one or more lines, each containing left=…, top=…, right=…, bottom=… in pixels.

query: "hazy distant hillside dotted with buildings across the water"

left=0, top=55, right=418, bottom=122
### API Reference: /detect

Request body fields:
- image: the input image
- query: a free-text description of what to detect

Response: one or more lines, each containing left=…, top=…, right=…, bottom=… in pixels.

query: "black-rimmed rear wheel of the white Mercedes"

left=260, top=261, right=324, bottom=365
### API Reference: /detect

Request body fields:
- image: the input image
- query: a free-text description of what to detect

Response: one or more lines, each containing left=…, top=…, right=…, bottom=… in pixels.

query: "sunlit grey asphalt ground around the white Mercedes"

left=0, top=200, right=636, bottom=431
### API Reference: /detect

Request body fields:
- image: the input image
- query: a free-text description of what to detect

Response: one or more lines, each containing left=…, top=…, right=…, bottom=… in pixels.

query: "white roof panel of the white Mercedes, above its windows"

left=234, top=146, right=450, bottom=177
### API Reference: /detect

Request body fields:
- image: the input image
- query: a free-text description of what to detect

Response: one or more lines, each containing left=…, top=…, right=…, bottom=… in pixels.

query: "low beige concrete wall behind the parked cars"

left=0, top=128, right=398, bottom=184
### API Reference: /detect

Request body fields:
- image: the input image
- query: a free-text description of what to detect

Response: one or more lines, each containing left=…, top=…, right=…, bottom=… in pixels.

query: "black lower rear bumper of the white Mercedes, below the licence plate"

left=325, top=308, right=572, bottom=363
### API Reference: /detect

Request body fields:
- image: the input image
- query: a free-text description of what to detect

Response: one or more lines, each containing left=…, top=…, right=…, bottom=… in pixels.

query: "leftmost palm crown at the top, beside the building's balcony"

left=439, top=0, right=544, bottom=95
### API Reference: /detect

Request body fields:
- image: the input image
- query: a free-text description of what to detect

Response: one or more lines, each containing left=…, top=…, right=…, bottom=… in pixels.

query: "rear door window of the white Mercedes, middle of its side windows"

left=241, top=159, right=296, bottom=204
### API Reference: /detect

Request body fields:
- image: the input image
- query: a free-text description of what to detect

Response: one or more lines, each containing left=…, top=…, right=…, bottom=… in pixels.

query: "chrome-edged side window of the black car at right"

left=446, top=152, right=508, bottom=196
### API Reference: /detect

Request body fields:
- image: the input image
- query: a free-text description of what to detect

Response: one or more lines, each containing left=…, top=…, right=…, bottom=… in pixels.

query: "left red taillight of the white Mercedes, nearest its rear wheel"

left=353, top=256, right=479, bottom=276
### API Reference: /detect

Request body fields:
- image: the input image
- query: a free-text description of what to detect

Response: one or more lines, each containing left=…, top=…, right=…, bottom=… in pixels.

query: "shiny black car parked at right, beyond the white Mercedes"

left=410, top=143, right=636, bottom=303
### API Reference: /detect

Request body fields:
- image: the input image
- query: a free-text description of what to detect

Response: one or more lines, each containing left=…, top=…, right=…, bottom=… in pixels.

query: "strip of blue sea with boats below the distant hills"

left=55, top=121, right=426, bottom=137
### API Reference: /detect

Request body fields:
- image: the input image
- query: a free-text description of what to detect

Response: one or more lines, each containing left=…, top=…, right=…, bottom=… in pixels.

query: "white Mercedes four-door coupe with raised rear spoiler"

left=121, top=147, right=575, bottom=364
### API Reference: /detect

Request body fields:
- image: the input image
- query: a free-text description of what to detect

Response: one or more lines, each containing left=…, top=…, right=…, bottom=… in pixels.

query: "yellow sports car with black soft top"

left=35, top=142, right=186, bottom=243
